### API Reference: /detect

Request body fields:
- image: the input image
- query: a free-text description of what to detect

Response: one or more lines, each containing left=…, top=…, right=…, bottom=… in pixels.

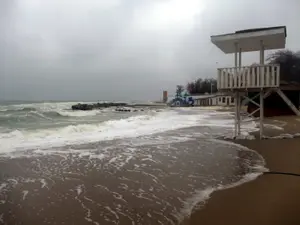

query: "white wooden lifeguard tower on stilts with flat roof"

left=211, top=26, right=300, bottom=138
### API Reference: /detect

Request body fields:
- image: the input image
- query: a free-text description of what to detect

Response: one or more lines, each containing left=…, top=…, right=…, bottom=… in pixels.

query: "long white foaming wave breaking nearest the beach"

left=0, top=111, right=205, bottom=153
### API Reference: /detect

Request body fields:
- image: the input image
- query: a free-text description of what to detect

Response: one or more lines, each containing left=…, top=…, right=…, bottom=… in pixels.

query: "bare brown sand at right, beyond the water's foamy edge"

left=186, top=117, right=300, bottom=225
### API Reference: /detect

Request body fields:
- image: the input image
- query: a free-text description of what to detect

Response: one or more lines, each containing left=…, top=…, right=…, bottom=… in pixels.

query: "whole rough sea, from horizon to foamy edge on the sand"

left=0, top=102, right=265, bottom=225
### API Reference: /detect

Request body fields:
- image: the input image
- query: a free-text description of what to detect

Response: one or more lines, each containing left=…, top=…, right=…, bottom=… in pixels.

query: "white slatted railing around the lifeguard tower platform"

left=218, top=65, right=280, bottom=90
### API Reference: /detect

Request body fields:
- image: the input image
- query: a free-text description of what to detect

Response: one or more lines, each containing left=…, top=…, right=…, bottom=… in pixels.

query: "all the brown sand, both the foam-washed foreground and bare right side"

left=0, top=114, right=300, bottom=225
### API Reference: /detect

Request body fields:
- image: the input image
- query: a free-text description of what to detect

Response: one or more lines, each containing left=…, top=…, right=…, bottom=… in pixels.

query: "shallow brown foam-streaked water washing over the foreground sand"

left=0, top=127, right=263, bottom=225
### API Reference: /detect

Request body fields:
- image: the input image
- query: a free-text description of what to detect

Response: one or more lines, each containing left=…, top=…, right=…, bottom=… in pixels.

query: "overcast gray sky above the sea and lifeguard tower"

left=0, top=0, right=300, bottom=100
